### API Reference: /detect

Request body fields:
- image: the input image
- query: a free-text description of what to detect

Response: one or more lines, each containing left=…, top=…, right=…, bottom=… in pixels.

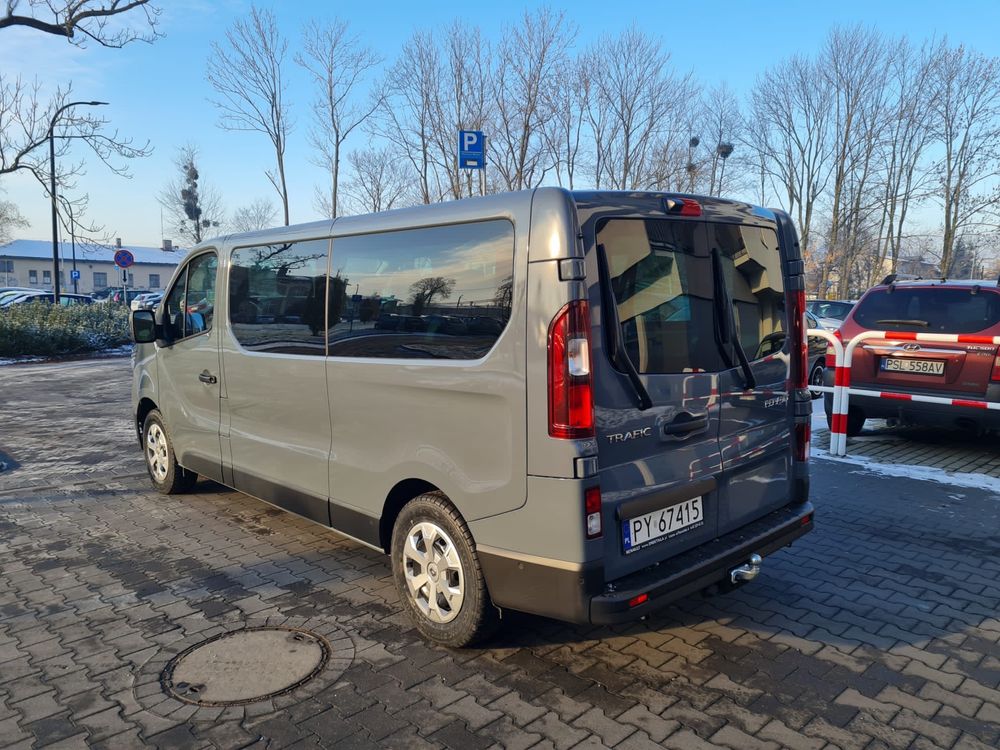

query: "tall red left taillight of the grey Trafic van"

left=549, top=300, right=594, bottom=440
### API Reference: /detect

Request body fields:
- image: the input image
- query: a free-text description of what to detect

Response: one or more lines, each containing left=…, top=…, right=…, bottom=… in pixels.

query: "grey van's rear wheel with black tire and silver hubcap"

left=390, top=492, right=500, bottom=648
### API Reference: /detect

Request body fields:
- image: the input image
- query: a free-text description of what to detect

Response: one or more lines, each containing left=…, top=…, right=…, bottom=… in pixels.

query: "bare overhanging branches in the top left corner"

left=0, top=0, right=161, bottom=47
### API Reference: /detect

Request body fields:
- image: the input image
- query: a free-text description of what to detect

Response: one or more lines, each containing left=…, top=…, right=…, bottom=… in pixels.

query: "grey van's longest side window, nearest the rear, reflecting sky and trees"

left=329, top=220, right=514, bottom=359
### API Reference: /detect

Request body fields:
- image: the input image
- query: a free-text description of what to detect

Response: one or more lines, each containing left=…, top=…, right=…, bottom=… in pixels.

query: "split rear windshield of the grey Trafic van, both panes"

left=597, top=219, right=784, bottom=373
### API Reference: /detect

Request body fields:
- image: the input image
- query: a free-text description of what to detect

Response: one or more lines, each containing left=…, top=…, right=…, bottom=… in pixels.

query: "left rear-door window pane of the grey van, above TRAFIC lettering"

left=597, top=219, right=720, bottom=373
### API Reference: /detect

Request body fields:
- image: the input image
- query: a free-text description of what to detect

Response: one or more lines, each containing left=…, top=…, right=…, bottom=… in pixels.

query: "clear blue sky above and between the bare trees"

left=0, top=0, right=1000, bottom=245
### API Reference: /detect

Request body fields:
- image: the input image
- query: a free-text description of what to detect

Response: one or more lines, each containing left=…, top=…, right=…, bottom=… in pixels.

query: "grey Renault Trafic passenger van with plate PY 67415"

left=132, top=188, right=813, bottom=646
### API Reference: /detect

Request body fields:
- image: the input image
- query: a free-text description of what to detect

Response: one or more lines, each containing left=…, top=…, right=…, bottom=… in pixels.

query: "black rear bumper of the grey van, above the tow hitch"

left=478, top=502, right=814, bottom=625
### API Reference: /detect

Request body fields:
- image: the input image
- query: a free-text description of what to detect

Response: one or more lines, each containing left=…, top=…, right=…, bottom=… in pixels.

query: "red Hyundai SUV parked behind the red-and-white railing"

left=825, top=276, right=1000, bottom=436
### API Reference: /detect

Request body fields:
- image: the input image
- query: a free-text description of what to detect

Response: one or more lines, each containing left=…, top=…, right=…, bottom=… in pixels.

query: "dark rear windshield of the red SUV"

left=854, top=287, right=1000, bottom=333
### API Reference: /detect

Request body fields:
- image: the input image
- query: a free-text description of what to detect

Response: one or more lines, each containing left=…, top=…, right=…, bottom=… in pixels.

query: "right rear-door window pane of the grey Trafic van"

left=707, top=224, right=785, bottom=359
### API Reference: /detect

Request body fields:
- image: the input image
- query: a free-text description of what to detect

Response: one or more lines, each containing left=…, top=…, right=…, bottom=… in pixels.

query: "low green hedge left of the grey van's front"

left=0, top=302, right=132, bottom=357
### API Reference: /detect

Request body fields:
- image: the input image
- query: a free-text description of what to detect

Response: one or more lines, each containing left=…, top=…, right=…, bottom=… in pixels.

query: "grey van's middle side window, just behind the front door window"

left=229, top=240, right=330, bottom=357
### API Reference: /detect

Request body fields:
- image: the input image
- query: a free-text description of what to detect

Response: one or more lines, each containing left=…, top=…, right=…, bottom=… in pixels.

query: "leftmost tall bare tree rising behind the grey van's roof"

left=207, top=6, right=292, bottom=226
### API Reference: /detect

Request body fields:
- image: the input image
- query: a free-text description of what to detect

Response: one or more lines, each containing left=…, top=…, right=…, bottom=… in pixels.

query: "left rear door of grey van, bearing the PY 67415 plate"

left=583, top=214, right=722, bottom=580
